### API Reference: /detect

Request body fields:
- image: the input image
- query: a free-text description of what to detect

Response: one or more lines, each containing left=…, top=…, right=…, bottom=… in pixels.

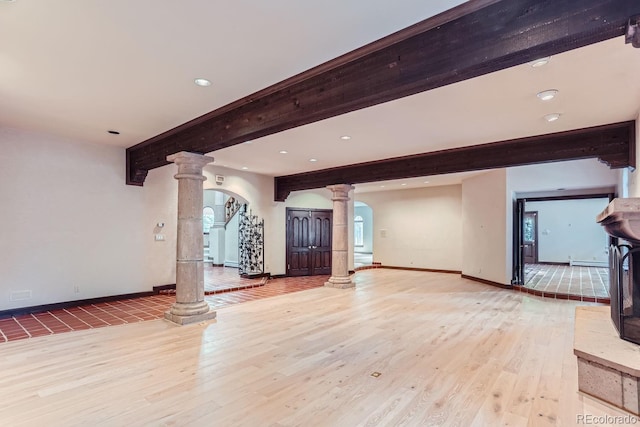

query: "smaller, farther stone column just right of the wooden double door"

left=324, top=184, right=355, bottom=289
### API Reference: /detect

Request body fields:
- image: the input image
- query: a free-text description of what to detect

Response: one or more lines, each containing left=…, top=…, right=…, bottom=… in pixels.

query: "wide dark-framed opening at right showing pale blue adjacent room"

left=513, top=194, right=612, bottom=299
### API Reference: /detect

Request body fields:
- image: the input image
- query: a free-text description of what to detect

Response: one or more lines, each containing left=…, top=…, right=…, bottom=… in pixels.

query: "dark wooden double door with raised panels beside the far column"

left=287, top=208, right=333, bottom=276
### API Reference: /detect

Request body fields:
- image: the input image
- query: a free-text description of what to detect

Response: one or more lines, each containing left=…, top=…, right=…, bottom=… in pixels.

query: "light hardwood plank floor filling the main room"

left=0, top=269, right=626, bottom=427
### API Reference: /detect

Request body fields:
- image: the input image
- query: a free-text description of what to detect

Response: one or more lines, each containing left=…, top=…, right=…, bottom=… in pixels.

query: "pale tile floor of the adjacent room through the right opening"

left=525, top=264, right=609, bottom=299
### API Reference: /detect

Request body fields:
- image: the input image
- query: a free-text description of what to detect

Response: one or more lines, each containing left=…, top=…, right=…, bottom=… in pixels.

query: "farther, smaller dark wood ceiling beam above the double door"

left=274, top=121, right=635, bottom=202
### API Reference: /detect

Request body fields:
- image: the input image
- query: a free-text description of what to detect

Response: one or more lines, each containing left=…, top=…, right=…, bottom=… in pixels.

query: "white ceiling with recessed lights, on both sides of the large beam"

left=0, top=0, right=640, bottom=190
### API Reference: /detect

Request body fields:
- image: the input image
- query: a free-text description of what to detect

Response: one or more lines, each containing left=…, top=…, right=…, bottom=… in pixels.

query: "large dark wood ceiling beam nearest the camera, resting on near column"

left=127, top=0, right=640, bottom=185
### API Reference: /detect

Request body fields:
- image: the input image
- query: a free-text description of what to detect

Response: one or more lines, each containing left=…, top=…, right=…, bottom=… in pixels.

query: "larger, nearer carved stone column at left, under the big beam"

left=164, top=151, right=216, bottom=325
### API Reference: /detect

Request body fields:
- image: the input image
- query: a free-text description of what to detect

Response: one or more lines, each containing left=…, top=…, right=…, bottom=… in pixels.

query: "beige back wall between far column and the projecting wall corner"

left=355, top=185, right=462, bottom=271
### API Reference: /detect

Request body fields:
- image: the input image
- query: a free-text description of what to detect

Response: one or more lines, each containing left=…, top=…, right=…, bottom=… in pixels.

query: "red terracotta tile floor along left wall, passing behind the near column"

left=0, top=274, right=329, bottom=343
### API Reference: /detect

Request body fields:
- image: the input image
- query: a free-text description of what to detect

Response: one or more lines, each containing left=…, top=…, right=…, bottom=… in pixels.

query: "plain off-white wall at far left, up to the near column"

left=0, top=128, right=154, bottom=310
